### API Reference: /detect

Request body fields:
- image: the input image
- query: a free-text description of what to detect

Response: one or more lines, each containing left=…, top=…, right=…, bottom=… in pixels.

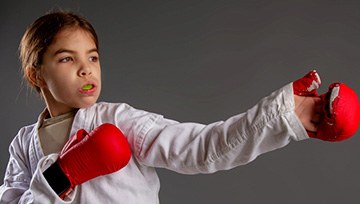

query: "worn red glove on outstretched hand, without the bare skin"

left=293, top=70, right=360, bottom=142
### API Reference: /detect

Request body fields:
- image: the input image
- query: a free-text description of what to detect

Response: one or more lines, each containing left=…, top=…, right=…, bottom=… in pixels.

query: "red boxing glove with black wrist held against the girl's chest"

left=44, top=123, right=131, bottom=198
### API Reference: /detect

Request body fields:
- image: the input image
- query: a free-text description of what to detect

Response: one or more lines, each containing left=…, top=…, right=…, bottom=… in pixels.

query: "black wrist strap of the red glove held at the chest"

left=43, top=162, right=70, bottom=196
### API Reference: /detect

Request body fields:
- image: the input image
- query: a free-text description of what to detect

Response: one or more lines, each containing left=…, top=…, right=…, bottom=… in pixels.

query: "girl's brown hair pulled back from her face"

left=19, top=11, right=99, bottom=92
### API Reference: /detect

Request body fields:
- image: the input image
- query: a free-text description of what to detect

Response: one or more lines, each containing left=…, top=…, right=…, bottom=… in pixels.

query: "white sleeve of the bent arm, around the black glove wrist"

left=0, top=137, right=76, bottom=204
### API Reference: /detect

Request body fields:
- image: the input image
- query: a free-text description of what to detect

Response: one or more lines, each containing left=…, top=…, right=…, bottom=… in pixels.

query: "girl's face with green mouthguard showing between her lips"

left=41, top=29, right=101, bottom=116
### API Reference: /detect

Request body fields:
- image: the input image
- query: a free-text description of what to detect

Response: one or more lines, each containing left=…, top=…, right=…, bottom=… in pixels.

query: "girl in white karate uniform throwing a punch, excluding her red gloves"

left=0, top=12, right=320, bottom=204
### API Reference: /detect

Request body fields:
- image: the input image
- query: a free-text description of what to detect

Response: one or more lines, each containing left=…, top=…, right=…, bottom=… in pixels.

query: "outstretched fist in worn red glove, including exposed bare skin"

left=293, top=70, right=360, bottom=141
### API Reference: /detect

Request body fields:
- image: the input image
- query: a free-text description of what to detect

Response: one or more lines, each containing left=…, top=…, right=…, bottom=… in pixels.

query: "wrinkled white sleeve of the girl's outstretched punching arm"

left=136, top=84, right=308, bottom=174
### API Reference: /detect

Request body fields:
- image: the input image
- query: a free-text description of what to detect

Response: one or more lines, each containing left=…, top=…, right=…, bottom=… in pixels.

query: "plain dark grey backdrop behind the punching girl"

left=0, top=0, right=360, bottom=204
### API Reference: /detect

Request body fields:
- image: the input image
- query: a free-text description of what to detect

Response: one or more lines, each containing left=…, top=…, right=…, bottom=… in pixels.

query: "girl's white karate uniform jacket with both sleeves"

left=0, top=84, right=308, bottom=204
